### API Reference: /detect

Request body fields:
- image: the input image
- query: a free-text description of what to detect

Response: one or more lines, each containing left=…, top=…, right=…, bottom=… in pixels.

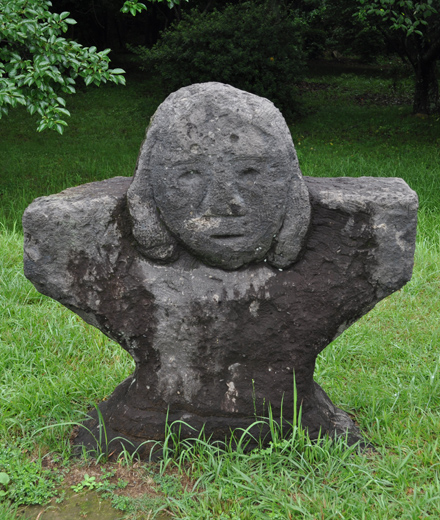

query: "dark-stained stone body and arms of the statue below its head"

left=23, top=174, right=417, bottom=450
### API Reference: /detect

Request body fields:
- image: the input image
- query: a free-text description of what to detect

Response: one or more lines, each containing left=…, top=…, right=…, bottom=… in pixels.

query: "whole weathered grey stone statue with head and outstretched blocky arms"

left=23, top=83, right=417, bottom=456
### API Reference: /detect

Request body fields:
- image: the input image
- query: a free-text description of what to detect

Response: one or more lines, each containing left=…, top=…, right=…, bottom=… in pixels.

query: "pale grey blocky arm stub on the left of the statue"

left=23, top=177, right=131, bottom=325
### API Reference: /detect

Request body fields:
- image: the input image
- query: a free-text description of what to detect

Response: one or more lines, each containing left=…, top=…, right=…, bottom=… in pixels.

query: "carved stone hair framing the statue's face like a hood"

left=127, top=83, right=310, bottom=269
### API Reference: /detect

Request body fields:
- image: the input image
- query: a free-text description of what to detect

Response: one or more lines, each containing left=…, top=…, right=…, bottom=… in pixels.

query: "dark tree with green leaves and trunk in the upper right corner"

left=358, top=0, right=440, bottom=114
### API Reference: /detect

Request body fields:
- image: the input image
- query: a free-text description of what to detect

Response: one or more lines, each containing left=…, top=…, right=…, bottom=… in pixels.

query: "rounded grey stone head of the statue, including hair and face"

left=128, top=83, right=310, bottom=269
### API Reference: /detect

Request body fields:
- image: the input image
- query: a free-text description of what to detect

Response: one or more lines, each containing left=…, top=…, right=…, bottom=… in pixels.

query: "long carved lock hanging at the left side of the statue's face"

left=127, top=168, right=178, bottom=262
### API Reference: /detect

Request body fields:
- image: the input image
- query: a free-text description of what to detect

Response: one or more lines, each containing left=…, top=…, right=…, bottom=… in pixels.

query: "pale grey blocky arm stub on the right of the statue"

left=305, top=177, right=418, bottom=299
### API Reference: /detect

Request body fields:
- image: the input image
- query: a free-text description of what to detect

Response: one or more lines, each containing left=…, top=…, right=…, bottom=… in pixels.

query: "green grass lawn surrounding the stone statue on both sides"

left=0, top=67, right=440, bottom=520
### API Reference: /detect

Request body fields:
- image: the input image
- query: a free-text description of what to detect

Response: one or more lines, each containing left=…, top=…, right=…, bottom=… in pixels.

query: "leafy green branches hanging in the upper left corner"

left=0, top=0, right=185, bottom=134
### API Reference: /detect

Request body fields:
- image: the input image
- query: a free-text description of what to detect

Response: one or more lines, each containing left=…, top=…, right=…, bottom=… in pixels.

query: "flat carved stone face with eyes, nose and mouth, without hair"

left=149, top=125, right=291, bottom=269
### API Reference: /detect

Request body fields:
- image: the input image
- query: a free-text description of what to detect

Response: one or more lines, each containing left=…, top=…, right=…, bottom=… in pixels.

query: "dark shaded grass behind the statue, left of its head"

left=0, top=73, right=162, bottom=227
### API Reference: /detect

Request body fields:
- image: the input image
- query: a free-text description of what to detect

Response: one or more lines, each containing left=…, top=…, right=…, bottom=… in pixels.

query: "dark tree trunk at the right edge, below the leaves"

left=413, top=59, right=440, bottom=114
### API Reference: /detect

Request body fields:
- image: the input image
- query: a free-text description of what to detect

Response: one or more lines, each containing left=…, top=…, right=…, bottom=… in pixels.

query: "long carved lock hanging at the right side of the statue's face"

left=267, top=175, right=311, bottom=269
